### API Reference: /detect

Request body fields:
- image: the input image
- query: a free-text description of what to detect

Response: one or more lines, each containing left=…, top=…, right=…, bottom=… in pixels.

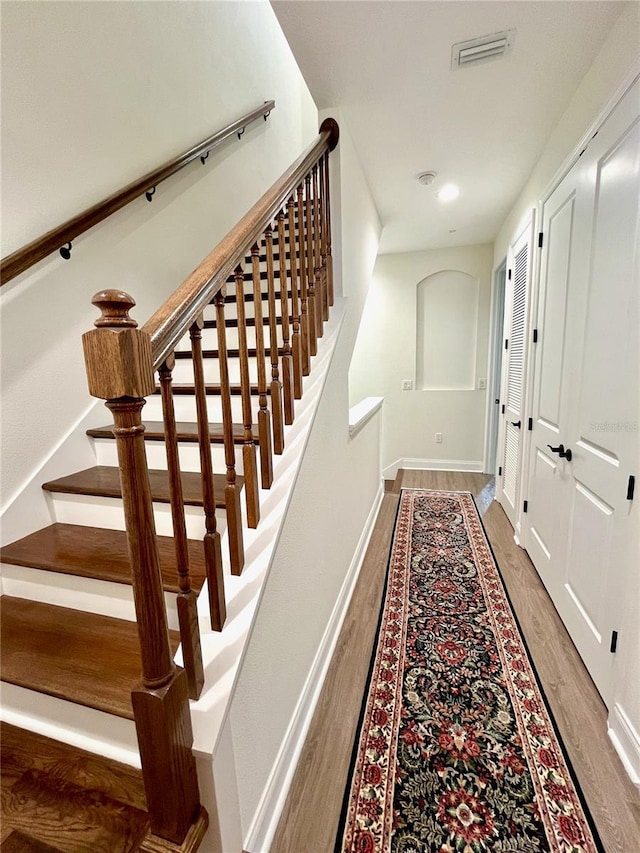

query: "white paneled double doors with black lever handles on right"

left=524, top=84, right=640, bottom=704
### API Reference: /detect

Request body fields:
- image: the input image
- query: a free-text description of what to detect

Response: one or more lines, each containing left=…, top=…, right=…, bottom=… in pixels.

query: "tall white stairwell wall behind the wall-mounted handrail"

left=1, top=0, right=318, bottom=512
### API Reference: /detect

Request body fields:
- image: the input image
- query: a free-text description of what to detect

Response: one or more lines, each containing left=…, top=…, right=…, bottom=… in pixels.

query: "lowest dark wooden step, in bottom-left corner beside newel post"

left=0, top=723, right=148, bottom=853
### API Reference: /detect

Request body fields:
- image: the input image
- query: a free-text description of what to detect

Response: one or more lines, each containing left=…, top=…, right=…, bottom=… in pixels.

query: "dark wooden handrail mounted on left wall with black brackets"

left=0, top=101, right=275, bottom=285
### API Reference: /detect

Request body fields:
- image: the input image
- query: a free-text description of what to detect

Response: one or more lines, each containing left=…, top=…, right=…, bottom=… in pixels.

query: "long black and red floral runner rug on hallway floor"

left=336, top=489, right=603, bottom=853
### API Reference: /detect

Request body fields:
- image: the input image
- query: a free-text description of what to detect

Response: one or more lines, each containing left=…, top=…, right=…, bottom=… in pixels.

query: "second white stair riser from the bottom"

left=2, top=563, right=179, bottom=630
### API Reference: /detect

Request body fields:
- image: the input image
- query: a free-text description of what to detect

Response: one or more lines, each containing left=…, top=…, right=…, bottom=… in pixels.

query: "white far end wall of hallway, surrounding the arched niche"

left=349, top=245, right=493, bottom=476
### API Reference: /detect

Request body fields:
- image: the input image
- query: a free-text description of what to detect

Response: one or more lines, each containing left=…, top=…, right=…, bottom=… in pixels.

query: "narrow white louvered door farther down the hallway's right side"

left=497, top=216, right=532, bottom=527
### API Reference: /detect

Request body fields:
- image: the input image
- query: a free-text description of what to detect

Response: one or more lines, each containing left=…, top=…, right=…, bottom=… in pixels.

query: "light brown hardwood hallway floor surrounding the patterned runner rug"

left=270, top=471, right=640, bottom=853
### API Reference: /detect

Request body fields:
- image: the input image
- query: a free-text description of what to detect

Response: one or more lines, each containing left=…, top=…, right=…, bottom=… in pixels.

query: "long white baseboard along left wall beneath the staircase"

left=244, top=481, right=384, bottom=853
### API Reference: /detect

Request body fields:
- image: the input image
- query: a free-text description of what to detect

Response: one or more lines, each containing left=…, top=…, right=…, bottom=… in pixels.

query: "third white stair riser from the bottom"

left=50, top=492, right=226, bottom=539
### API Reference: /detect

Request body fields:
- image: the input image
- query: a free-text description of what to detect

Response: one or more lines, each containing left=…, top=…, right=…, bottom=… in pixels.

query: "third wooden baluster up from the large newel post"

left=213, top=285, right=244, bottom=575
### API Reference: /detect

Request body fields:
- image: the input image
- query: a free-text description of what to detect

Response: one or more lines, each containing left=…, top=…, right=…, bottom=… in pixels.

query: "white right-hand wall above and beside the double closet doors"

left=494, top=3, right=640, bottom=784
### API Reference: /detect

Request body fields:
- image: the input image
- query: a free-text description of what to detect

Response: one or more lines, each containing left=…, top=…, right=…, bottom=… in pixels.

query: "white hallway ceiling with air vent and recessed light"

left=272, top=0, right=625, bottom=252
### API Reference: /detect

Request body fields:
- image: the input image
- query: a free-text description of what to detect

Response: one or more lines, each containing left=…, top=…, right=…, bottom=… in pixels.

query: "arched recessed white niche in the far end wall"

left=416, top=270, right=480, bottom=391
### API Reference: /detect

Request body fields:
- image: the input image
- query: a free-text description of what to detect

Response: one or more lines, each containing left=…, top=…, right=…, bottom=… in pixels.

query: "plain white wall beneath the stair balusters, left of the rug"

left=230, top=110, right=381, bottom=850
